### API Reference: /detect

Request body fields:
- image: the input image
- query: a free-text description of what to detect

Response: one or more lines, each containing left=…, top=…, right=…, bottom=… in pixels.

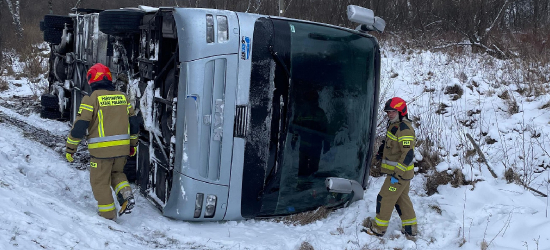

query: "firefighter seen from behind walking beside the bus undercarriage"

left=65, top=63, right=139, bottom=220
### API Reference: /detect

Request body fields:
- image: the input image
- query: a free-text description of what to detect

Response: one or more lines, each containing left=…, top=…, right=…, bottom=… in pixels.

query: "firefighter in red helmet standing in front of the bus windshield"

left=364, top=97, right=418, bottom=236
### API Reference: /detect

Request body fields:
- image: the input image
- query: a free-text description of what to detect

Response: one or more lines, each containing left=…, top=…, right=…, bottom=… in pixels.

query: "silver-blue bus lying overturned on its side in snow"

left=41, top=6, right=385, bottom=221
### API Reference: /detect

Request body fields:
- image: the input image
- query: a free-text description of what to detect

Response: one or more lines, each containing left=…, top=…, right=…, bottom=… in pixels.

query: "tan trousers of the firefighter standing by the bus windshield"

left=373, top=175, right=417, bottom=235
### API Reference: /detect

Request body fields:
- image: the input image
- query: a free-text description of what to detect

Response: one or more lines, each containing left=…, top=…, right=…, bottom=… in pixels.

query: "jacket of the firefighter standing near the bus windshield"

left=381, top=118, right=416, bottom=180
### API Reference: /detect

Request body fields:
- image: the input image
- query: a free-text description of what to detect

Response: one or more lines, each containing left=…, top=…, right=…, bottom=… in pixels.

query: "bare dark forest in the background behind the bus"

left=0, top=0, right=550, bottom=62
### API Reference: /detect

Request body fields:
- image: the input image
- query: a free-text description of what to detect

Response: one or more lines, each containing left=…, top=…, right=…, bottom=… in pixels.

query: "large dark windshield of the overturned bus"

left=260, top=20, right=378, bottom=216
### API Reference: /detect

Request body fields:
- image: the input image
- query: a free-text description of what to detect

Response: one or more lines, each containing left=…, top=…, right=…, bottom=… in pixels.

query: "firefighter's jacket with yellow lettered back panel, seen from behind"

left=66, top=88, right=139, bottom=158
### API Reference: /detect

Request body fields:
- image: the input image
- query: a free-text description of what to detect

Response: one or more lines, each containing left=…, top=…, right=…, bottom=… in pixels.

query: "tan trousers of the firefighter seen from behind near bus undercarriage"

left=90, top=156, right=132, bottom=219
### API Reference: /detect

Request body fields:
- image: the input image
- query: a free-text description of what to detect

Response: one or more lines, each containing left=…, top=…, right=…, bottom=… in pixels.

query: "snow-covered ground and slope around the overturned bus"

left=0, top=45, right=550, bottom=250
